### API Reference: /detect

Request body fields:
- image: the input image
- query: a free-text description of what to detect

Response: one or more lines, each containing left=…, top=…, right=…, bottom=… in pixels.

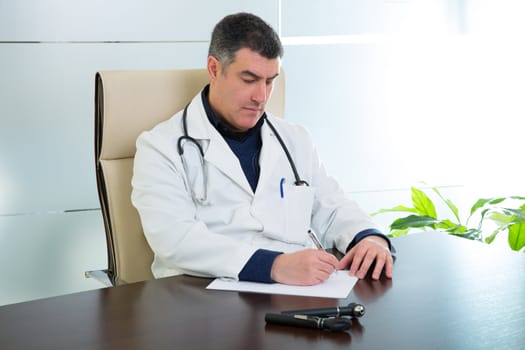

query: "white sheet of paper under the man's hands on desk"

left=206, top=270, right=357, bottom=299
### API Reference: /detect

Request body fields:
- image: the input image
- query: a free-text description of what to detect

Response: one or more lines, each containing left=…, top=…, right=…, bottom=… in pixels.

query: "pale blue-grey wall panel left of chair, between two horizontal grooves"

left=0, top=43, right=207, bottom=214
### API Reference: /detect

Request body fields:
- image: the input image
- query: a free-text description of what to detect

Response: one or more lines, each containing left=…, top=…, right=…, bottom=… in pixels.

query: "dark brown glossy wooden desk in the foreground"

left=0, top=233, right=525, bottom=350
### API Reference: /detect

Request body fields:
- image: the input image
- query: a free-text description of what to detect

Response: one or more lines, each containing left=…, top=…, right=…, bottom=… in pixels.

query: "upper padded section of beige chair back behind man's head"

left=95, top=69, right=284, bottom=160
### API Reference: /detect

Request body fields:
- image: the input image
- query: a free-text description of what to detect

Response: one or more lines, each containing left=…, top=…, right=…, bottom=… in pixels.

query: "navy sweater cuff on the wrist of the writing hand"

left=239, top=249, right=282, bottom=283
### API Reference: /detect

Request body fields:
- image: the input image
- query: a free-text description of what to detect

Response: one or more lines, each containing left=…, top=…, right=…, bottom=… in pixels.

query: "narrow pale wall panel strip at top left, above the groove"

left=0, top=0, right=278, bottom=41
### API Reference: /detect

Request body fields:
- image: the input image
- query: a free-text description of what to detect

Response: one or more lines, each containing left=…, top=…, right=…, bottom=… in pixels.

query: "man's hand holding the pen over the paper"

left=271, top=249, right=339, bottom=286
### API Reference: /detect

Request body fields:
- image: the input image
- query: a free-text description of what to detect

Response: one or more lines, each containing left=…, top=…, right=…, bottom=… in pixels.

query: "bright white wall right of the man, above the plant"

left=281, top=0, right=525, bottom=224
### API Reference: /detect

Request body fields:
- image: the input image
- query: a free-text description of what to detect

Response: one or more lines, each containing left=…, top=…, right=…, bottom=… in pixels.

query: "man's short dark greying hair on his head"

left=208, top=12, right=284, bottom=68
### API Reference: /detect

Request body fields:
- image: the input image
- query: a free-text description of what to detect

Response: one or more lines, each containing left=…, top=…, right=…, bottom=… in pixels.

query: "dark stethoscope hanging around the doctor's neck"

left=177, top=103, right=309, bottom=204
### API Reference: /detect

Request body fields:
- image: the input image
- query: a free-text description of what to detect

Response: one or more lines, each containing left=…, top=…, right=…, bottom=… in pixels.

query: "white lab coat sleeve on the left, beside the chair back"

left=132, top=118, right=256, bottom=279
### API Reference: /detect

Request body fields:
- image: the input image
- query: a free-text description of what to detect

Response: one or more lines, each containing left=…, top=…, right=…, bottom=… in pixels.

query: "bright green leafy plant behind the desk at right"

left=372, top=186, right=525, bottom=251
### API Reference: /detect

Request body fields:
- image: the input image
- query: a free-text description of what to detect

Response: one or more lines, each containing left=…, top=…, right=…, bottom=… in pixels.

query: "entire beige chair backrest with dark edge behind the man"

left=95, top=69, right=285, bottom=285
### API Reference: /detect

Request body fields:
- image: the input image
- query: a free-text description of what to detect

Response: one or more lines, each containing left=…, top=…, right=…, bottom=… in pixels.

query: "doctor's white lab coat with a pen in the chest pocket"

left=132, top=94, right=380, bottom=279
